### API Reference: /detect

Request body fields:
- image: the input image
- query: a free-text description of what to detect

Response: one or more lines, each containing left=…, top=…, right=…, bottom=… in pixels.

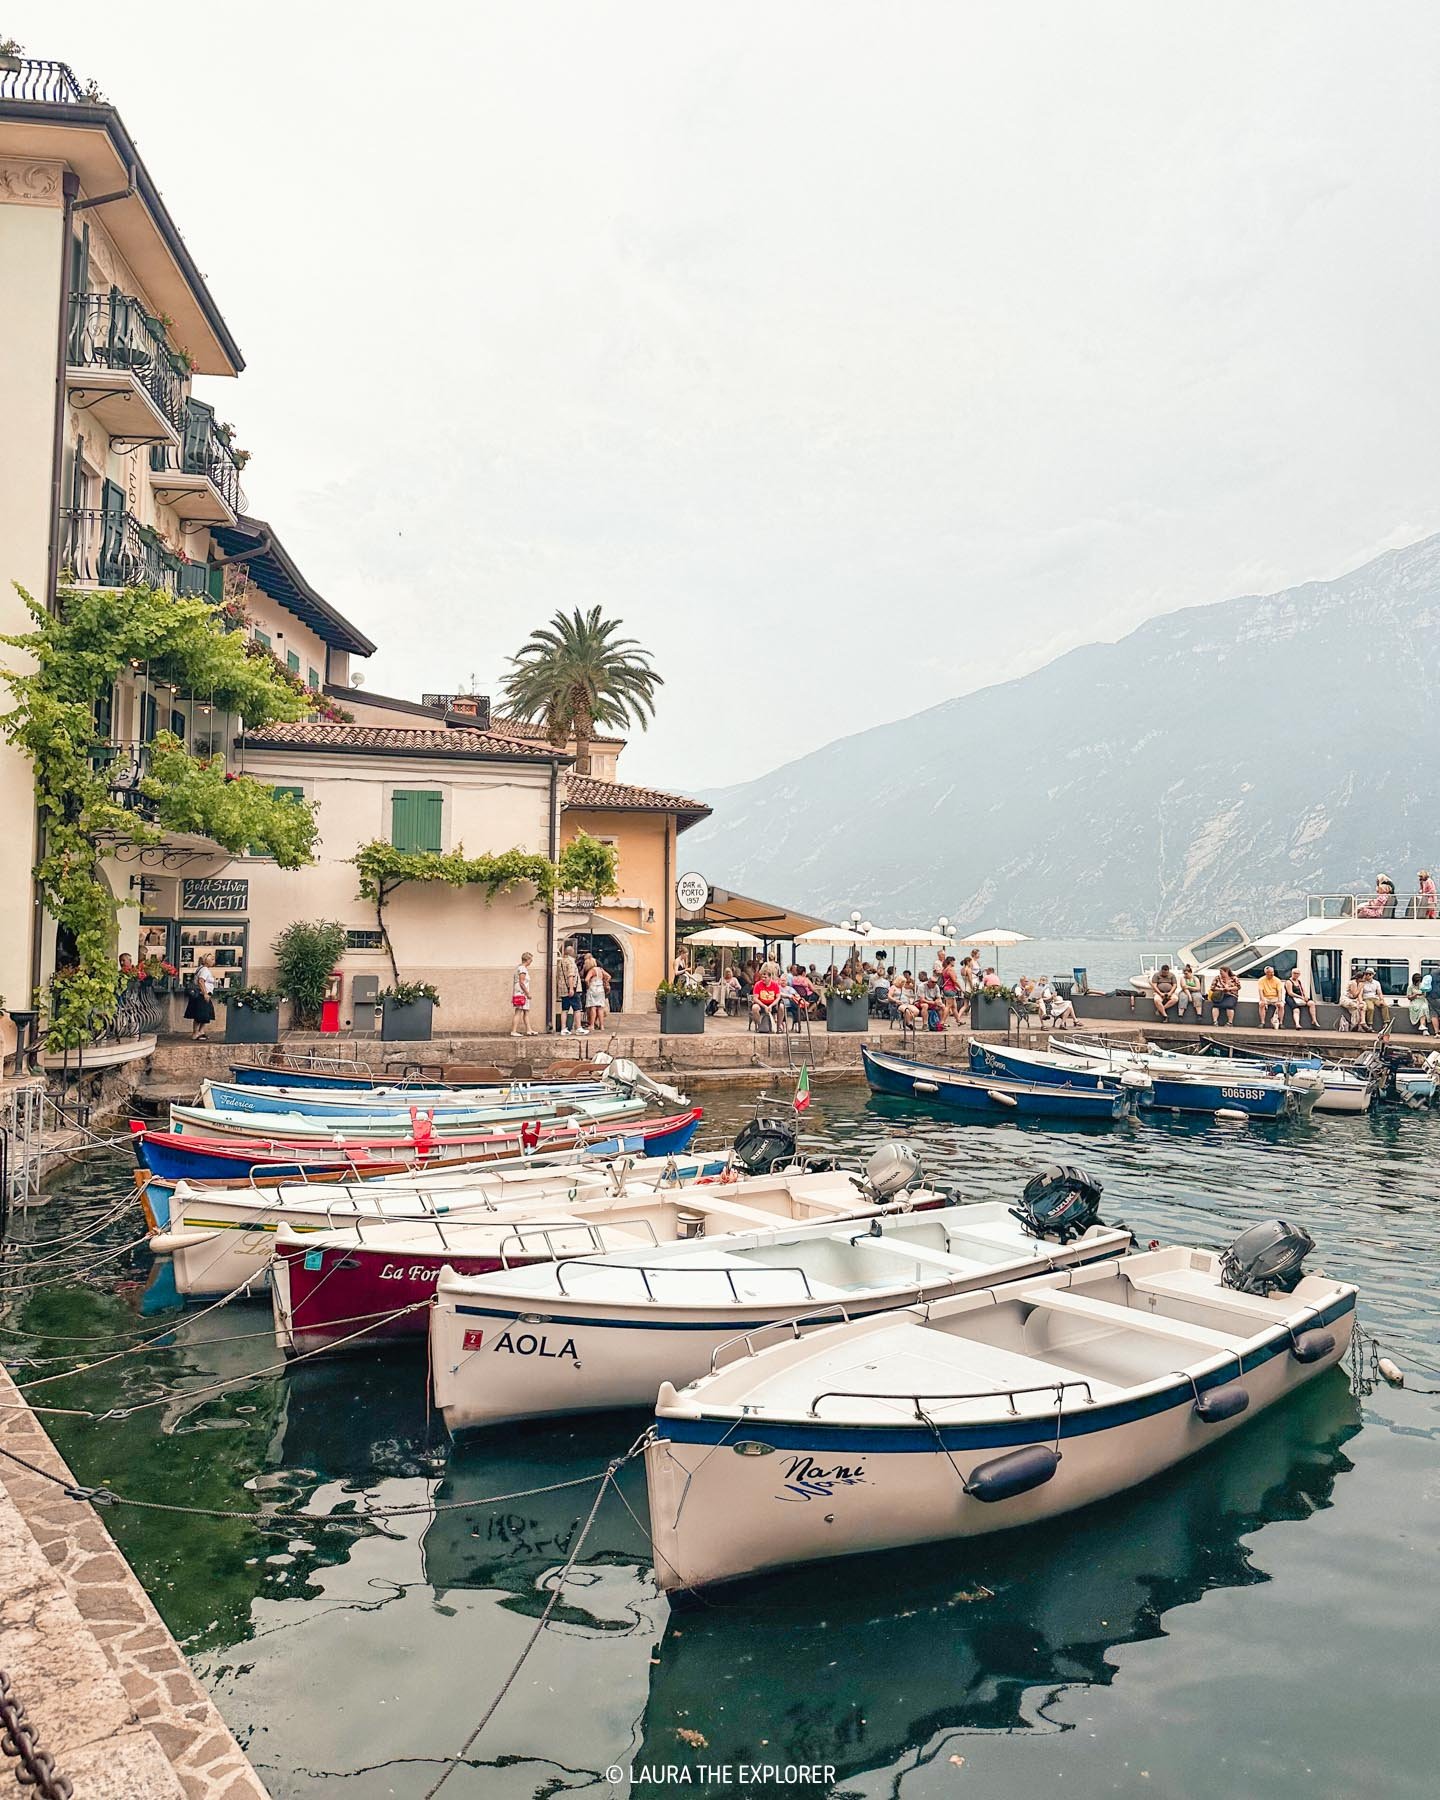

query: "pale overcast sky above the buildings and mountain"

left=19, top=0, right=1440, bottom=788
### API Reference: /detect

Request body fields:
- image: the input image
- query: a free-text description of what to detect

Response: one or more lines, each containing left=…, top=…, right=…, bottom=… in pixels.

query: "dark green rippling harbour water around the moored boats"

left=0, top=1085, right=1440, bottom=1800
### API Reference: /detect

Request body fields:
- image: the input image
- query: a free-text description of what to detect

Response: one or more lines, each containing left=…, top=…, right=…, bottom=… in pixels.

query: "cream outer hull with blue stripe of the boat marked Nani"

left=644, top=1292, right=1354, bottom=1593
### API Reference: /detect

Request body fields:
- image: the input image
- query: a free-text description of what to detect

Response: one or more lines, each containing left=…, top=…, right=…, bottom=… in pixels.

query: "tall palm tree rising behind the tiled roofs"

left=502, top=607, right=664, bottom=776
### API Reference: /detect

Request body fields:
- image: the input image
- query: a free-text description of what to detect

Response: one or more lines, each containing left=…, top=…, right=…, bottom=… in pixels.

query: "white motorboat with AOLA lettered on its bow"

left=430, top=1152, right=1130, bottom=1433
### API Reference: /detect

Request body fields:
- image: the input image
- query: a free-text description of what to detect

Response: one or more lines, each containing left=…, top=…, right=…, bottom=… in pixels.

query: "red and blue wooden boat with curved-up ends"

left=130, top=1107, right=704, bottom=1183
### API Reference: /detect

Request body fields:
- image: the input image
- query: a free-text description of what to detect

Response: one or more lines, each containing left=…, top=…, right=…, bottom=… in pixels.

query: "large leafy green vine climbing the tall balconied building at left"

left=0, top=587, right=315, bottom=1049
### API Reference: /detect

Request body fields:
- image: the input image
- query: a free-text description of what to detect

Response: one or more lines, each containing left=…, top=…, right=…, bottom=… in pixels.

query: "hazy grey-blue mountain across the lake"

left=686, top=535, right=1440, bottom=938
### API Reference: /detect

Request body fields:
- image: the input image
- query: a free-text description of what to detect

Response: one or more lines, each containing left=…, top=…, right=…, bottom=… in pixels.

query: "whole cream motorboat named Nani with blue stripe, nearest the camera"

left=644, top=1220, right=1355, bottom=1595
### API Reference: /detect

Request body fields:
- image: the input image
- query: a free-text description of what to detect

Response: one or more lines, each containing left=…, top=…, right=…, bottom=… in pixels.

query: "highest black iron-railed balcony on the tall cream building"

left=65, top=288, right=185, bottom=448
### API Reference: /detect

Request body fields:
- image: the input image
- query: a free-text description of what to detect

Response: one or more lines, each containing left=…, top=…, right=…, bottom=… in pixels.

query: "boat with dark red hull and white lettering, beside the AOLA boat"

left=272, top=1159, right=936, bottom=1354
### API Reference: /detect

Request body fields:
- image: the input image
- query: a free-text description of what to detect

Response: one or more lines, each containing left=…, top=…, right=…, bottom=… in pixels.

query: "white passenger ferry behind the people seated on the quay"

left=1130, top=895, right=1440, bottom=1004
